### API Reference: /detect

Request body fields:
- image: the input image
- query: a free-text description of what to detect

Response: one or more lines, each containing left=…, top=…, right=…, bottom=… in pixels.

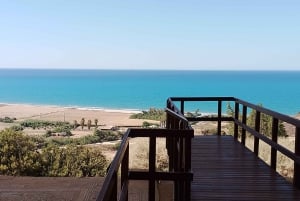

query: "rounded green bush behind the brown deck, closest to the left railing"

left=41, top=145, right=107, bottom=177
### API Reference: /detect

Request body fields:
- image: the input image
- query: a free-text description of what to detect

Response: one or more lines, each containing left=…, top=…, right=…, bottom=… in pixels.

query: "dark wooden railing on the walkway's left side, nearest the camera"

left=97, top=109, right=194, bottom=201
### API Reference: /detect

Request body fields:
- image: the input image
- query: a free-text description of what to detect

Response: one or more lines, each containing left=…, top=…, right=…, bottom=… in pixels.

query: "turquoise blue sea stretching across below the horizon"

left=0, top=69, right=300, bottom=115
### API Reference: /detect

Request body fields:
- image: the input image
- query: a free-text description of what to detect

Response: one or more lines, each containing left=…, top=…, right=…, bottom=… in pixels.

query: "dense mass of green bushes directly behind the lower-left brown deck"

left=0, top=129, right=107, bottom=176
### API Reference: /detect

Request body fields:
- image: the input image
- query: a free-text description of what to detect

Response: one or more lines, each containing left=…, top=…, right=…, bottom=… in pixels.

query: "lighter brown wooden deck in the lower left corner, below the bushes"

left=0, top=175, right=104, bottom=201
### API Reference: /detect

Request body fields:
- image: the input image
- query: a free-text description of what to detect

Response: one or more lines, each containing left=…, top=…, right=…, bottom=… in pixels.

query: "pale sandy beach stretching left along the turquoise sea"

left=0, top=104, right=151, bottom=132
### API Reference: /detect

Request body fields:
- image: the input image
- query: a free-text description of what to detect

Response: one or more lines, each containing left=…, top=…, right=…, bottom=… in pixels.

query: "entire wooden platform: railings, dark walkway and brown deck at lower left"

left=0, top=97, right=300, bottom=201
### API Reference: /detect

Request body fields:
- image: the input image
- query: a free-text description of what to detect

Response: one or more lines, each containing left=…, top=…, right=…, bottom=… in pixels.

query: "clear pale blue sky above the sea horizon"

left=0, top=0, right=300, bottom=70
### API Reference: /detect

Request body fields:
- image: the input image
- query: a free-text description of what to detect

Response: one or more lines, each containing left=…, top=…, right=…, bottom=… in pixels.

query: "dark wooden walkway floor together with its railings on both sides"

left=97, top=97, right=300, bottom=201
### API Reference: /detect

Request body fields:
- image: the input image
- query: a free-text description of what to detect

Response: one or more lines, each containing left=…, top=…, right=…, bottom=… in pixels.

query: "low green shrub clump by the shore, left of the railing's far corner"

left=130, top=108, right=166, bottom=121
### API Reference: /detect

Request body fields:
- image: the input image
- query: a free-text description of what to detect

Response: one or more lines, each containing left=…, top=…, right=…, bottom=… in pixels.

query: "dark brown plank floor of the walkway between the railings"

left=191, top=136, right=300, bottom=201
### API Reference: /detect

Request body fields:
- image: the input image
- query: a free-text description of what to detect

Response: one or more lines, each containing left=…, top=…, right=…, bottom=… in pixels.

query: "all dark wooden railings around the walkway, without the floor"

left=97, top=97, right=300, bottom=201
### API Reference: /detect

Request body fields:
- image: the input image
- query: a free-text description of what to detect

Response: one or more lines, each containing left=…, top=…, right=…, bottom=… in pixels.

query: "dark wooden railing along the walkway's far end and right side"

left=167, top=97, right=300, bottom=188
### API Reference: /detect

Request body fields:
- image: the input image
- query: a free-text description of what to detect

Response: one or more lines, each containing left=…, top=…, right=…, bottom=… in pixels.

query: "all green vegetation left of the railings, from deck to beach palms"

left=0, top=118, right=122, bottom=177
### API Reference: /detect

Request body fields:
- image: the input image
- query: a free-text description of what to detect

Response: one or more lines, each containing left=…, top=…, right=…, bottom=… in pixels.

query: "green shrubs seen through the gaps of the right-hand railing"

left=227, top=103, right=287, bottom=137
